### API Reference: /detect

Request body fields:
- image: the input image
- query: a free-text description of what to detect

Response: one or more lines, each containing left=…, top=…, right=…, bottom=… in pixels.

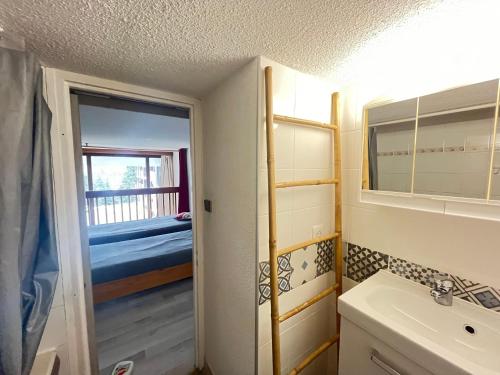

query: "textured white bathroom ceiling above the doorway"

left=0, top=0, right=440, bottom=97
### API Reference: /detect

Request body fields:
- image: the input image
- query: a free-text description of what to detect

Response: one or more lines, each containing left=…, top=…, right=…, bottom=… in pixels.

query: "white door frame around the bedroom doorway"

left=44, top=68, right=205, bottom=375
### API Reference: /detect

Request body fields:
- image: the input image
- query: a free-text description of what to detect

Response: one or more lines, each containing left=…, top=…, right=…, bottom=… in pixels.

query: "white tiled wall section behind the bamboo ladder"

left=258, top=58, right=336, bottom=375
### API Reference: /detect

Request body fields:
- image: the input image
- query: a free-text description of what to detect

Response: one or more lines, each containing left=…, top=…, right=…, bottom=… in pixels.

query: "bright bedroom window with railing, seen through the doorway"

left=82, top=146, right=179, bottom=225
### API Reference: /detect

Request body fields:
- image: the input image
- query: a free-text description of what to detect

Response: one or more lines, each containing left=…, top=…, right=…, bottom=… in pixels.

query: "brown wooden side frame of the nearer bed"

left=92, top=262, right=193, bottom=305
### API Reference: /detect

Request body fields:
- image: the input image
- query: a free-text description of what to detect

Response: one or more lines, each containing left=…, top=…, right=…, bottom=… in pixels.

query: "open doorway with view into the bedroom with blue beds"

left=71, top=90, right=196, bottom=375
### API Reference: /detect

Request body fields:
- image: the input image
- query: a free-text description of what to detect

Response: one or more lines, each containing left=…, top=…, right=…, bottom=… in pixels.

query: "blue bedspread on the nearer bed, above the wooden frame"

left=90, top=230, right=193, bottom=284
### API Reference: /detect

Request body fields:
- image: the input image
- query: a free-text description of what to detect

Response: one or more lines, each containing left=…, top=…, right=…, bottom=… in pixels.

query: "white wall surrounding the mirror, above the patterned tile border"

left=339, top=1, right=500, bottom=287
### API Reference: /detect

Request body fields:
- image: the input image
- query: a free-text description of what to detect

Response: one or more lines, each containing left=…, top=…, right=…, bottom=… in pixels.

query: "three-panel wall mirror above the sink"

left=362, top=80, right=500, bottom=203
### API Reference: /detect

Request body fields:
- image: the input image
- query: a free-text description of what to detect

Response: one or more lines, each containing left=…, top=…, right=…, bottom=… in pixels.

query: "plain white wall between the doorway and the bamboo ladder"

left=202, top=60, right=258, bottom=375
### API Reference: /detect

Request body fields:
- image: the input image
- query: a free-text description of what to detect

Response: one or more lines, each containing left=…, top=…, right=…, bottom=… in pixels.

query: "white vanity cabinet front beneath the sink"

left=339, top=317, right=432, bottom=375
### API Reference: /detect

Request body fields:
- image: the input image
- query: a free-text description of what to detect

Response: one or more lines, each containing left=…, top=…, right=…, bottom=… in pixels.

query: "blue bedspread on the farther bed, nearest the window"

left=88, top=216, right=191, bottom=245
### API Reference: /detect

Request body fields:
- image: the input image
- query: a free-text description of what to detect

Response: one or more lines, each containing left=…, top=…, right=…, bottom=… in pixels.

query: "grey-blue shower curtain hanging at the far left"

left=0, top=48, right=59, bottom=375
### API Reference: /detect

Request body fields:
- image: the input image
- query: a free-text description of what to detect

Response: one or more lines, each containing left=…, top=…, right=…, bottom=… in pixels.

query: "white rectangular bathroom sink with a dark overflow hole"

left=339, top=271, right=500, bottom=375
